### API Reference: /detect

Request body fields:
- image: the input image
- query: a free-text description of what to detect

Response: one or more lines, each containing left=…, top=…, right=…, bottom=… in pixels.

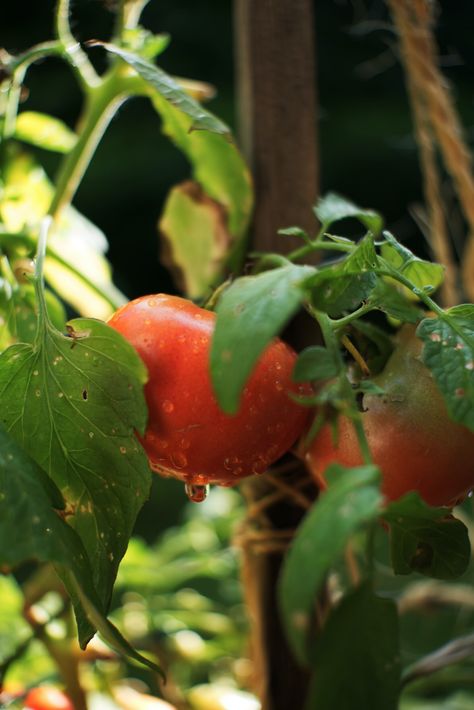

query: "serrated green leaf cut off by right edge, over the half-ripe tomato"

left=416, top=312, right=474, bottom=431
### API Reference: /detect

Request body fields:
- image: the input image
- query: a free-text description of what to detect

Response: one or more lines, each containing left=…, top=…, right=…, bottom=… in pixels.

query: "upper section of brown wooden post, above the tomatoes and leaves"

left=235, top=0, right=318, bottom=253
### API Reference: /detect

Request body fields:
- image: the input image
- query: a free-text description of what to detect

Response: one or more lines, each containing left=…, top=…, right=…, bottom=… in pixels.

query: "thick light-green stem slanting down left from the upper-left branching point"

left=48, top=72, right=127, bottom=219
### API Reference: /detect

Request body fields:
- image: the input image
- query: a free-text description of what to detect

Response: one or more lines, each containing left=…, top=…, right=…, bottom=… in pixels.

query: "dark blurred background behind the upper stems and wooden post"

left=0, top=0, right=474, bottom=539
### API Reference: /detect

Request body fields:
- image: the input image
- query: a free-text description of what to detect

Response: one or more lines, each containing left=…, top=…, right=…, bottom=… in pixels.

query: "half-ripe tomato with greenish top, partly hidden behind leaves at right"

left=306, top=326, right=474, bottom=507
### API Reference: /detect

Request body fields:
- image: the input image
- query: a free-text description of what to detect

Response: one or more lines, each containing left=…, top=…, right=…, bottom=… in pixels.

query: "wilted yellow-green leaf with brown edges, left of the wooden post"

left=160, top=181, right=232, bottom=298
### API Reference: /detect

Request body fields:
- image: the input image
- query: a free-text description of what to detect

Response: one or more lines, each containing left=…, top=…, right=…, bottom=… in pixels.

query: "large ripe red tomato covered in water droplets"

left=109, top=294, right=308, bottom=486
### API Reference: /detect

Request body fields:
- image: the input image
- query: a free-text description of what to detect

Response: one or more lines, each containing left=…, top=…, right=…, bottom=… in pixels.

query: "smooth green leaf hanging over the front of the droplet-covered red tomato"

left=211, top=264, right=313, bottom=414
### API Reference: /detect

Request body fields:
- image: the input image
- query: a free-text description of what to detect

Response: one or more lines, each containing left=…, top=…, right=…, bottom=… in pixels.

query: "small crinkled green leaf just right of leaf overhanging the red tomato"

left=305, top=234, right=377, bottom=317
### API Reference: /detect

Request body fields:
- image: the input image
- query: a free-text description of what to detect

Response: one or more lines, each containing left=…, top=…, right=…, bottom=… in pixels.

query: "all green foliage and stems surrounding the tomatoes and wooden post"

left=0, top=0, right=474, bottom=710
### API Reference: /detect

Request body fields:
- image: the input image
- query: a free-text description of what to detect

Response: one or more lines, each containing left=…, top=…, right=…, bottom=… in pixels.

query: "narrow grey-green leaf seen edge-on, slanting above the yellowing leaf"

left=92, top=40, right=230, bottom=136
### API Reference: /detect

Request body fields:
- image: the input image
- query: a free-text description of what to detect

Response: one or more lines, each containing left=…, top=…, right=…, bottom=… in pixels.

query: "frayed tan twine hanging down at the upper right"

left=387, top=0, right=474, bottom=306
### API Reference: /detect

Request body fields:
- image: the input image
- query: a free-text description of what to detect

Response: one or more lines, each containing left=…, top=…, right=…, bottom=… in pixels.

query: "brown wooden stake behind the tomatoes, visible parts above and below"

left=234, top=0, right=318, bottom=710
